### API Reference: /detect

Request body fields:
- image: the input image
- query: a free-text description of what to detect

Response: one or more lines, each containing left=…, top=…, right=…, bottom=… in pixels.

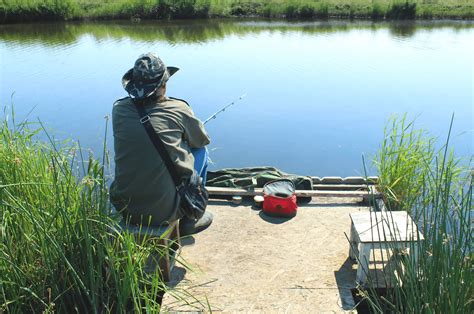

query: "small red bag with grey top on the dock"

left=263, top=179, right=298, bottom=217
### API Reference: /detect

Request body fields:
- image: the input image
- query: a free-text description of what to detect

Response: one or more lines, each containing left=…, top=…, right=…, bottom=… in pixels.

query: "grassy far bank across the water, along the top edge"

left=0, top=0, right=474, bottom=23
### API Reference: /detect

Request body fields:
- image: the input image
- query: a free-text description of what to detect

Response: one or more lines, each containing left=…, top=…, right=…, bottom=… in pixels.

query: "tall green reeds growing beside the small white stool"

left=360, top=114, right=474, bottom=313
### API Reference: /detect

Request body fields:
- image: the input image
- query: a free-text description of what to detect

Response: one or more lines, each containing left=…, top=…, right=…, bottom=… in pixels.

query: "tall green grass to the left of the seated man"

left=0, top=108, right=180, bottom=313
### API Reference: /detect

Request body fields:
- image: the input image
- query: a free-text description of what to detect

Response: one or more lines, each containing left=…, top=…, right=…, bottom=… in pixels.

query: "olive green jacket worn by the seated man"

left=110, top=98, right=210, bottom=225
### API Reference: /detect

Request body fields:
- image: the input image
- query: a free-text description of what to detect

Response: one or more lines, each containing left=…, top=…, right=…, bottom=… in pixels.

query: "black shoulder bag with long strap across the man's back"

left=132, top=99, right=209, bottom=220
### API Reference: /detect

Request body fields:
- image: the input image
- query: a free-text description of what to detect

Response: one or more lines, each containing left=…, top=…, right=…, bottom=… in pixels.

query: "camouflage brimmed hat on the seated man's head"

left=122, top=53, right=179, bottom=99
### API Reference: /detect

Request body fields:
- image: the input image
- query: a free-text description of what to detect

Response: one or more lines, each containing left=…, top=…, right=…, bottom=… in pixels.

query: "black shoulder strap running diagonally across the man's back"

left=132, top=98, right=181, bottom=186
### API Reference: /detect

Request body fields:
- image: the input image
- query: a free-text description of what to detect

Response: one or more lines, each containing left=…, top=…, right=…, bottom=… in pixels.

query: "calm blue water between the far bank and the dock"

left=0, top=20, right=474, bottom=176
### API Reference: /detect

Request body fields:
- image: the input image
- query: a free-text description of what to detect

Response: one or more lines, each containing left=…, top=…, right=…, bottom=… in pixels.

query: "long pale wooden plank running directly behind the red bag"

left=206, top=187, right=380, bottom=197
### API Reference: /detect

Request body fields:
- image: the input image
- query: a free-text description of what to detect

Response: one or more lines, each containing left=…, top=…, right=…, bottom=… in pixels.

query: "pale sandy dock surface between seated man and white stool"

left=162, top=198, right=368, bottom=313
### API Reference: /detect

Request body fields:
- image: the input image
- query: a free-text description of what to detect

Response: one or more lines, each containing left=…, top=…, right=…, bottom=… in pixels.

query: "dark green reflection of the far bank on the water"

left=0, top=19, right=474, bottom=45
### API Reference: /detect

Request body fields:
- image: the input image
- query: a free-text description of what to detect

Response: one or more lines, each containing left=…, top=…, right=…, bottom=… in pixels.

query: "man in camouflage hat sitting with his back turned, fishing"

left=110, top=53, right=212, bottom=235
